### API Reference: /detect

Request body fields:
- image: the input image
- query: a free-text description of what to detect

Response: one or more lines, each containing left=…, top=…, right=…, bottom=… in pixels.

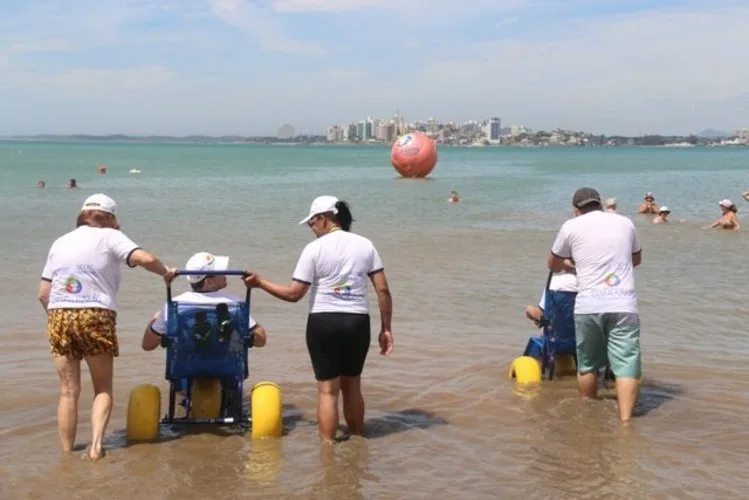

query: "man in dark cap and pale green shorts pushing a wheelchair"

left=548, top=187, right=642, bottom=422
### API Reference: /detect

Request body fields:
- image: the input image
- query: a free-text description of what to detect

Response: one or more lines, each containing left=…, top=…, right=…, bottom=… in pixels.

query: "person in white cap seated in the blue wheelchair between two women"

left=141, top=252, right=267, bottom=351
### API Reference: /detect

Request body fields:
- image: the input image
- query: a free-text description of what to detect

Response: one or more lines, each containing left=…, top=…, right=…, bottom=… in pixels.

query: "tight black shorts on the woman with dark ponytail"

left=307, top=312, right=371, bottom=381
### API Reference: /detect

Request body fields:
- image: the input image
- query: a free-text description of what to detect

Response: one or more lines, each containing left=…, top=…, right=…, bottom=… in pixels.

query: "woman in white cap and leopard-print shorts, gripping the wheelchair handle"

left=39, top=194, right=174, bottom=460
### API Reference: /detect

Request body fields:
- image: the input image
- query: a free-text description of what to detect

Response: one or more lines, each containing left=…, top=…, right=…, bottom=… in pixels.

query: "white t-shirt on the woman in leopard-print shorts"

left=42, top=226, right=139, bottom=311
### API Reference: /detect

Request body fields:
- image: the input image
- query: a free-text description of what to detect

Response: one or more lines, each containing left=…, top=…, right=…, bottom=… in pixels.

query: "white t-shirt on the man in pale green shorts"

left=551, top=210, right=642, bottom=314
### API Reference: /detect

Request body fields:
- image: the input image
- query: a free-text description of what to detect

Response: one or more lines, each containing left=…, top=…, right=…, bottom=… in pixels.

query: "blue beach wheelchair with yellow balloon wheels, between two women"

left=127, top=269, right=283, bottom=441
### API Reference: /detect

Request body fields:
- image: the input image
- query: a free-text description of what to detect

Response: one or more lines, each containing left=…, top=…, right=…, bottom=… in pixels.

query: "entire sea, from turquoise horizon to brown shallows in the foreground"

left=0, top=141, right=749, bottom=498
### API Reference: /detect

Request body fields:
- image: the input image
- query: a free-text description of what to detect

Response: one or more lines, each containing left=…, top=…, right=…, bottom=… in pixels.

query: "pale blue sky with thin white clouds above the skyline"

left=0, top=0, right=749, bottom=136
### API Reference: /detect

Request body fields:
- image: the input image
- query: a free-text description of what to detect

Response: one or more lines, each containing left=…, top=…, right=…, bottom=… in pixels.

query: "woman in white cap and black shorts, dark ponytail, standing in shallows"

left=245, top=196, right=393, bottom=440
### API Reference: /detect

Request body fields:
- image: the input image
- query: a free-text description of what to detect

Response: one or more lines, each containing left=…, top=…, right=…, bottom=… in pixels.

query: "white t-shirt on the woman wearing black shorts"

left=292, top=230, right=383, bottom=314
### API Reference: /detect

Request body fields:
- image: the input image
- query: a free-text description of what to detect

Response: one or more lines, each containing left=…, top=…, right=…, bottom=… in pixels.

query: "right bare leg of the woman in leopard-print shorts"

left=86, top=354, right=114, bottom=460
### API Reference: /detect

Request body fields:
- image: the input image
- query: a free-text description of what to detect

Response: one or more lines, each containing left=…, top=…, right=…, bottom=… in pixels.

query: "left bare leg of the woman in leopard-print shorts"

left=55, top=356, right=81, bottom=453
